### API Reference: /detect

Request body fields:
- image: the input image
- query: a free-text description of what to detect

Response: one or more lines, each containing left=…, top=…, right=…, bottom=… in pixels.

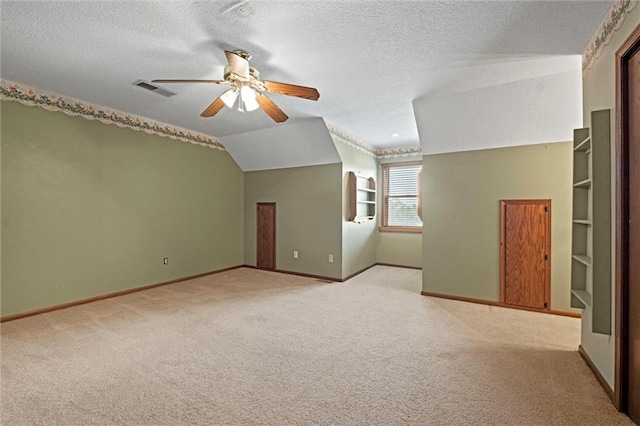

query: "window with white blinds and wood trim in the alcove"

left=380, top=162, right=422, bottom=232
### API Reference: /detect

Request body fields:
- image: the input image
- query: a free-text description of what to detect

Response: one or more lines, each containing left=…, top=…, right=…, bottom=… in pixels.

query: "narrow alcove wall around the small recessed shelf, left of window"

left=334, top=137, right=380, bottom=278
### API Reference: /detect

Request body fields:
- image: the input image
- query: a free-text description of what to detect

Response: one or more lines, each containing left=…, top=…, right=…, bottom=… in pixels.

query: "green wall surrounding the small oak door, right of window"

left=422, top=142, right=573, bottom=311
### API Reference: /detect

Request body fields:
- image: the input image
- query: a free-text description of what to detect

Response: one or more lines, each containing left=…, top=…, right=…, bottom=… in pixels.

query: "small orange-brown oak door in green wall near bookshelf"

left=500, top=200, right=551, bottom=309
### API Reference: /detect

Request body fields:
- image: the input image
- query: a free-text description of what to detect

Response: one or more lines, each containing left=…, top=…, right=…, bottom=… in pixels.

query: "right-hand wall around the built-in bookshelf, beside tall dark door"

left=581, top=6, right=640, bottom=388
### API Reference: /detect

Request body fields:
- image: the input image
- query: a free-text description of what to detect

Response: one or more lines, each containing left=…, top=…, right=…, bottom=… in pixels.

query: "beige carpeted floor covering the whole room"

left=2, top=266, right=631, bottom=425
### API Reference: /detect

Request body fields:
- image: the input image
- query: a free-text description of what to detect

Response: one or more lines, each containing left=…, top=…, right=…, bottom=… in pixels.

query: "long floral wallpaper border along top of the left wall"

left=0, top=80, right=225, bottom=150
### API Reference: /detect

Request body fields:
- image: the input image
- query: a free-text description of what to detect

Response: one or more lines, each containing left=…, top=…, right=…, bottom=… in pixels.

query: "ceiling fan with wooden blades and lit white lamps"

left=153, top=50, right=320, bottom=123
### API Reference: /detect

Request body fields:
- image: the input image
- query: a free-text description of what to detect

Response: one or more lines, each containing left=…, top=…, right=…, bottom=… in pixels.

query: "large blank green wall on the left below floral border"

left=1, top=101, right=243, bottom=316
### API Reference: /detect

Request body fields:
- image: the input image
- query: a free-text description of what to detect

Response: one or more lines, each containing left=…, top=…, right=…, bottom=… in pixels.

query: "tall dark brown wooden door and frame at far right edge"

left=615, top=26, right=640, bottom=424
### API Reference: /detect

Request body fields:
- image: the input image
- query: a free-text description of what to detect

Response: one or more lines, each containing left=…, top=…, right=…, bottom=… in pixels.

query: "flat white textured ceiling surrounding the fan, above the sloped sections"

left=0, top=1, right=612, bottom=151
